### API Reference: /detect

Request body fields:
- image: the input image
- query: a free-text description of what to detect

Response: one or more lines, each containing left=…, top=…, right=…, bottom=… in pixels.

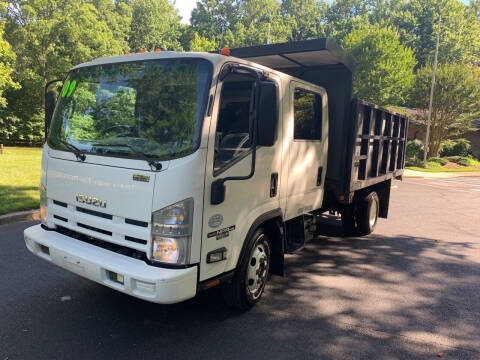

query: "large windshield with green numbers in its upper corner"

left=48, top=58, right=211, bottom=160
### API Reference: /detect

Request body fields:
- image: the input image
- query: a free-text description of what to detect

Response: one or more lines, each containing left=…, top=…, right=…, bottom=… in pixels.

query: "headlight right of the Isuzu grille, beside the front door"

left=151, top=198, right=193, bottom=265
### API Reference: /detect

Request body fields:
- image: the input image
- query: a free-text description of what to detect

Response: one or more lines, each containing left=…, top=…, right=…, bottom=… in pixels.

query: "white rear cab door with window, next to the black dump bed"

left=285, top=81, right=328, bottom=220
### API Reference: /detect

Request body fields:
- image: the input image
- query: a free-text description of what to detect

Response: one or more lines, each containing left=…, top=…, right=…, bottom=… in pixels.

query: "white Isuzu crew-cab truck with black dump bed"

left=24, top=39, right=408, bottom=309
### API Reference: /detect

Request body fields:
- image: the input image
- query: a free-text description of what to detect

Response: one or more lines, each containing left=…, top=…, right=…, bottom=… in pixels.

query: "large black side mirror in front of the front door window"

left=255, top=81, right=278, bottom=146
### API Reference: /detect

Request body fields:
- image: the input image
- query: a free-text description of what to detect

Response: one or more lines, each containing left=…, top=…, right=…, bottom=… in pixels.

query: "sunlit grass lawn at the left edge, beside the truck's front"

left=0, top=147, right=42, bottom=215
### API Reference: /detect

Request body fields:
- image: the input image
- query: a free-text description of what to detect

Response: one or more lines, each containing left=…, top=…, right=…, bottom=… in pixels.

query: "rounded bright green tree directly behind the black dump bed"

left=343, top=25, right=416, bottom=105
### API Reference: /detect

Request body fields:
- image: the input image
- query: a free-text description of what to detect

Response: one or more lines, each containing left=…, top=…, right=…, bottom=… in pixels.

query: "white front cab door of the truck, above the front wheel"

left=199, top=65, right=281, bottom=281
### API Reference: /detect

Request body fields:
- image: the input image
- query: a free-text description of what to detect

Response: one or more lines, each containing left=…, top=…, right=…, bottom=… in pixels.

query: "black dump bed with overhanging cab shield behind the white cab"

left=231, top=38, right=408, bottom=202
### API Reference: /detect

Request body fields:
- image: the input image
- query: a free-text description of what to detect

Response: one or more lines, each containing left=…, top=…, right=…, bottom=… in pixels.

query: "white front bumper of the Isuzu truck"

left=24, top=225, right=198, bottom=304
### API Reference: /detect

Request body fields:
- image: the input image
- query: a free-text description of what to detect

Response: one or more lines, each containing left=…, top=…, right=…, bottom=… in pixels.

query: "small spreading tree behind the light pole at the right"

left=411, top=64, right=480, bottom=156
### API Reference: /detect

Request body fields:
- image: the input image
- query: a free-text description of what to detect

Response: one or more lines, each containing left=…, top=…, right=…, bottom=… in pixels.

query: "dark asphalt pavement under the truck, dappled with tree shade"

left=0, top=177, right=480, bottom=360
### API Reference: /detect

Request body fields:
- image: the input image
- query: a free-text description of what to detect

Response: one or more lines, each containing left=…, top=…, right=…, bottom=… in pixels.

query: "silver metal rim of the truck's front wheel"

left=246, top=235, right=269, bottom=300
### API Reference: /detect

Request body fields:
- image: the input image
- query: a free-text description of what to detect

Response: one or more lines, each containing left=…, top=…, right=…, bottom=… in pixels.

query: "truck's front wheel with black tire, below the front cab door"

left=222, top=228, right=271, bottom=311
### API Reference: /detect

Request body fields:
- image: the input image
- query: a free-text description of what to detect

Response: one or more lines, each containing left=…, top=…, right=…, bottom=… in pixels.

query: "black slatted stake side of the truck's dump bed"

left=349, top=99, right=408, bottom=192
